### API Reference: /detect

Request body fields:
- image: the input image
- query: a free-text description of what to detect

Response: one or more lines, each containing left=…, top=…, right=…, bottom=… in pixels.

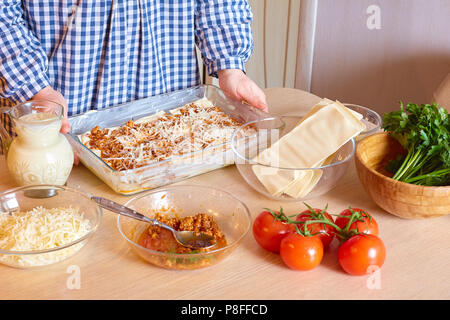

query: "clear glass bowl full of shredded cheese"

left=0, top=185, right=102, bottom=268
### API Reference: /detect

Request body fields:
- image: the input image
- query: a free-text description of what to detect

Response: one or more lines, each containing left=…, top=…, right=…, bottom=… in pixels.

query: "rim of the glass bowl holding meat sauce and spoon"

left=117, top=184, right=252, bottom=258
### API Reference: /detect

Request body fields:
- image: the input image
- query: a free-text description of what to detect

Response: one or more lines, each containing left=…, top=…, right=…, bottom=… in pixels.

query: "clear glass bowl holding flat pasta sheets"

left=231, top=116, right=355, bottom=202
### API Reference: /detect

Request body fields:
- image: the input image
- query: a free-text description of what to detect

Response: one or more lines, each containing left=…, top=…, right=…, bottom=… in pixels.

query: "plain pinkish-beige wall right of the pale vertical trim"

left=311, top=0, right=450, bottom=112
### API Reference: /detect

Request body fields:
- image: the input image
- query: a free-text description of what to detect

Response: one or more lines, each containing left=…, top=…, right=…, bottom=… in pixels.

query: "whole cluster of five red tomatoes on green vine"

left=253, top=204, right=386, bottom=275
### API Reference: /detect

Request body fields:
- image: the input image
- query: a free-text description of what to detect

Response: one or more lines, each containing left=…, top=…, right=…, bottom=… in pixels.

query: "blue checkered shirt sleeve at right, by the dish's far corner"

left=195, top=0, right=253, bottom=77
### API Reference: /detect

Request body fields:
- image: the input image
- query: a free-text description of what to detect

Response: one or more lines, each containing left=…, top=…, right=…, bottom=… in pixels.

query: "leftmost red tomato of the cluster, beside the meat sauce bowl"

left=253, top=211, right=294, bottom=253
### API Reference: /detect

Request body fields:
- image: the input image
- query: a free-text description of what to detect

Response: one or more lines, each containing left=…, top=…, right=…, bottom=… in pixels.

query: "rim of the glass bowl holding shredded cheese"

left=0, top=184, right=103, bottom=255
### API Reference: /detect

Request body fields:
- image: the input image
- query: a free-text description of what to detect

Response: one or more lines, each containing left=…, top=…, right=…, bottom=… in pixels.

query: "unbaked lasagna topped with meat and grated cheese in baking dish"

left=78, top=98, right=256, bottom=171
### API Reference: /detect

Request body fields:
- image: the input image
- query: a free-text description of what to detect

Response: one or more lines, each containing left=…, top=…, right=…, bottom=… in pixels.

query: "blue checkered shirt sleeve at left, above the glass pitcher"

left=0, top=0, right=49, bottom=103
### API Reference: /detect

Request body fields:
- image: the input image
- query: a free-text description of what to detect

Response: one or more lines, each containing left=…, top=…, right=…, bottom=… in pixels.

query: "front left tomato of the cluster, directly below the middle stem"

left=280, top=232, right=323, bottom=271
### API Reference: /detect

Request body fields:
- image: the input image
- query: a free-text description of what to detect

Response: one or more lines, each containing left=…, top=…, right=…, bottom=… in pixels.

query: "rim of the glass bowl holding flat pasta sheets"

left=230, top=116, right=356, bottom=171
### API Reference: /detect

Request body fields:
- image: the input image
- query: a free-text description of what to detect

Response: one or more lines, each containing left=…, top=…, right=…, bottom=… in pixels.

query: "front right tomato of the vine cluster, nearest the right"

left=338, top=234, right=386, bottom=275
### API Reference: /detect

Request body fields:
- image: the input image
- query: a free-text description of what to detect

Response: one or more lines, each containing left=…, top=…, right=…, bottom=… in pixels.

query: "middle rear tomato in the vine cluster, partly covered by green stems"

left=295, top=209, right=335, bottom=249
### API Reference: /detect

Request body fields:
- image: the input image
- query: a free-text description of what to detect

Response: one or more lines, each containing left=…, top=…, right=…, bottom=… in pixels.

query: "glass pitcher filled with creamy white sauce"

left=0, top=101, right=73, bottom=186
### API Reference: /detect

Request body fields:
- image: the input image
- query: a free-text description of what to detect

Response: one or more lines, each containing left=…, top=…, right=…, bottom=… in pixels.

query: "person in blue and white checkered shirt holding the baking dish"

left=0, top=0, right=267, bottom=139
